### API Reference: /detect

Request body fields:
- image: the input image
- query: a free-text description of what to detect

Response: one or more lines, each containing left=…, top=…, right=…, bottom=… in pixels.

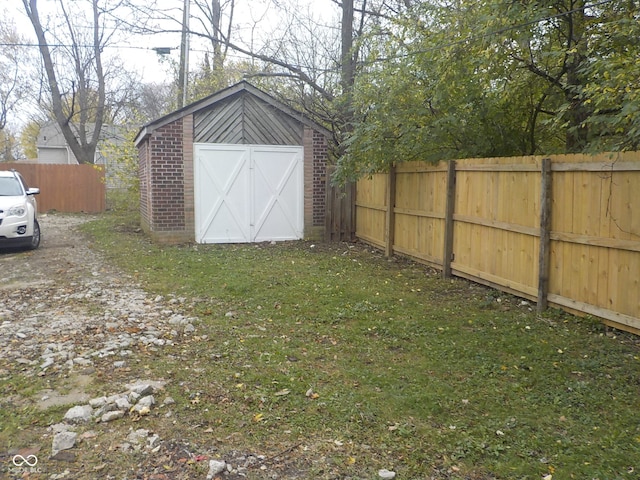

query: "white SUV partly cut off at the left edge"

left=0, top=170, right=40, bottom=249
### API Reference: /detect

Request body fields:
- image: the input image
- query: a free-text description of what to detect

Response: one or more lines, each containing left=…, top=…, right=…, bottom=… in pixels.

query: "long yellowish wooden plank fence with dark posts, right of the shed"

left=356, top=152, right=640, bottom=333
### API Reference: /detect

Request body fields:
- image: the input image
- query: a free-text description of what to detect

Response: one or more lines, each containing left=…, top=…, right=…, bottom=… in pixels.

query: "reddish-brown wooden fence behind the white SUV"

left=0, top=163, right=106, bottom=213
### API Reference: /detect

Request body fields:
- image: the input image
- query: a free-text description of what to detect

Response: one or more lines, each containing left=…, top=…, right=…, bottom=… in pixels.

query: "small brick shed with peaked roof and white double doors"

left=135, top=81, right=330, bottom=243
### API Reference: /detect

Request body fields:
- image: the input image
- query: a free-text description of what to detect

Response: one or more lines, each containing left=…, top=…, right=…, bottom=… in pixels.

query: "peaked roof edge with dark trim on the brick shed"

left=135, top=80, right=331, bottom=146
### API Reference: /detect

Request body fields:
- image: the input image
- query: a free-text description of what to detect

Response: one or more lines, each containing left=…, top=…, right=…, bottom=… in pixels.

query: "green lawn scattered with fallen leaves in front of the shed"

left=76, top=216, right=640, bottom=479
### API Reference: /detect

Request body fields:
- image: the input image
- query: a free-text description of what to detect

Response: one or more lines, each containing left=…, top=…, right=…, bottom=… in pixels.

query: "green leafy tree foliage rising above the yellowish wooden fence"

left=338, top=0, right=640, bottom=178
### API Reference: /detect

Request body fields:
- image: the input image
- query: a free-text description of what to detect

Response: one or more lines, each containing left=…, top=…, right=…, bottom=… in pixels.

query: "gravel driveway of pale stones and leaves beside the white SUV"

left=0, top=215, right=194, bottom=382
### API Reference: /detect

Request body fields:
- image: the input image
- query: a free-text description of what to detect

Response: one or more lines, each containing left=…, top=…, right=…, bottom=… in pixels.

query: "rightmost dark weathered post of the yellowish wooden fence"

left=537, top=158, right=552, bottom=313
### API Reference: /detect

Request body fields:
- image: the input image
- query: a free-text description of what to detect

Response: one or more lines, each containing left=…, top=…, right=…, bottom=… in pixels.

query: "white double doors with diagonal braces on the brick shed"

left=193, top=144, right=304, bottom=243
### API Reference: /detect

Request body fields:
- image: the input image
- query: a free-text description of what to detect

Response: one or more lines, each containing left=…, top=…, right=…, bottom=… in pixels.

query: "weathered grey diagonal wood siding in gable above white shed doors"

left=194, top=93, right=303, bottom=145
